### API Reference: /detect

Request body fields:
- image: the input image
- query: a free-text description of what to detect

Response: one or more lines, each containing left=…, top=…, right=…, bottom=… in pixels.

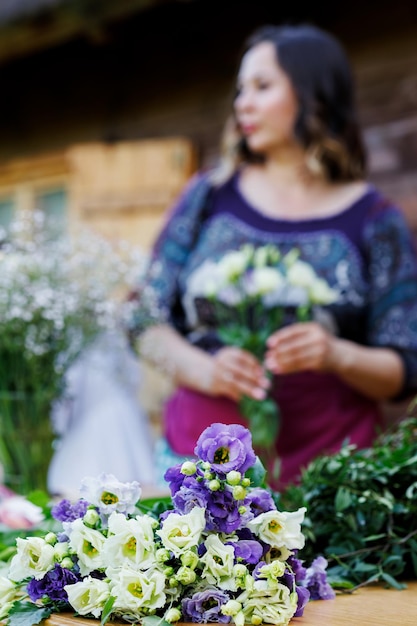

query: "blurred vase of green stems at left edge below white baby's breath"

left=0, top=390, right=55, bottom=495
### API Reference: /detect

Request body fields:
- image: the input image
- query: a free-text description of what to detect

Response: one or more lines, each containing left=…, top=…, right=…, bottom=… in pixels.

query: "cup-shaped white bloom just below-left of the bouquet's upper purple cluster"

left=156, top=506, right=206, bottom=556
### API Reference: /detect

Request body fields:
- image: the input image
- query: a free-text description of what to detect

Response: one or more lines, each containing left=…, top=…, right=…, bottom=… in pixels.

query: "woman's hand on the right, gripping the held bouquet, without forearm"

left=264, top=322, right=338, bottom=374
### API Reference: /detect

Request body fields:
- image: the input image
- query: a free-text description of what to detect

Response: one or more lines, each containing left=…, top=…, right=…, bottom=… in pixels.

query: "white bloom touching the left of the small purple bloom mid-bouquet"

left=200, top=535, right=236, bottom=590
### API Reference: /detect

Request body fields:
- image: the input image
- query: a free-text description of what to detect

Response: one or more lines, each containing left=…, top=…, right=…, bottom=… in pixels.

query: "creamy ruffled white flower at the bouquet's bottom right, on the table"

left=236, top=580, right=297, bottom=626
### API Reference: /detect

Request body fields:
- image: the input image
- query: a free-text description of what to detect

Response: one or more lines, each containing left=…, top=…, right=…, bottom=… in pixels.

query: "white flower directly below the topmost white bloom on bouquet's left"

left=69, top=518, right=106, bottom=576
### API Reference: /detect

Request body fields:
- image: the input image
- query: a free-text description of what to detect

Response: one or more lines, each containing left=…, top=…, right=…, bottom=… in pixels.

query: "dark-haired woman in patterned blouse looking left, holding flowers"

left=135, top=26, right=417, bottom=488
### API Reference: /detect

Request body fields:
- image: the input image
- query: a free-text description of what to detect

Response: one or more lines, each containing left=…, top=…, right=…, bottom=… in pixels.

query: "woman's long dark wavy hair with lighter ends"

left=218, top=24, right=366, bottom=182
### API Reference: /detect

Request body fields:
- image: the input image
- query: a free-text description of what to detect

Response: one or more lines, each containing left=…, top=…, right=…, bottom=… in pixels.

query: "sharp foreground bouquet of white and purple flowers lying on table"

left=0, top=424, right=333, bottom=626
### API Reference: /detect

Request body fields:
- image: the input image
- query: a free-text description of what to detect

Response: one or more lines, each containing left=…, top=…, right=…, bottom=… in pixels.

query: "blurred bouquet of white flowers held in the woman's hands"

left=184, top=244, right=337, bottom=468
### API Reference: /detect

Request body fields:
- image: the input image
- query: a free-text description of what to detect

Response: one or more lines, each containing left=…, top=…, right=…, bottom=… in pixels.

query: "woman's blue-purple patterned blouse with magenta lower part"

left=141, top=174, right=417, bottom=488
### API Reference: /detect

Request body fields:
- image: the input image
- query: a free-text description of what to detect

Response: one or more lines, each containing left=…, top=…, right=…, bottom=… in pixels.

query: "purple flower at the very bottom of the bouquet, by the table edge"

left=181, top=588, right=231, bottom=624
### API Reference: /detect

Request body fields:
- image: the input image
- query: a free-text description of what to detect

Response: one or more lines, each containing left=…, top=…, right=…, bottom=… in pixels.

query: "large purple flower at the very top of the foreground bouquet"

left=194, top=423, right=256, bottom=475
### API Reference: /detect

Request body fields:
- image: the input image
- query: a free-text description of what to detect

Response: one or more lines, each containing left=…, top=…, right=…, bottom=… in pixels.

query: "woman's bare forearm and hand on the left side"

left=139, top=324, right=269, bottom=401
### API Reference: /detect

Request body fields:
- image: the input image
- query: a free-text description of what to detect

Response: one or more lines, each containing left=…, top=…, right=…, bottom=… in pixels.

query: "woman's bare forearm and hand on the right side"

left=265, top=322, right=405, bottom=400
